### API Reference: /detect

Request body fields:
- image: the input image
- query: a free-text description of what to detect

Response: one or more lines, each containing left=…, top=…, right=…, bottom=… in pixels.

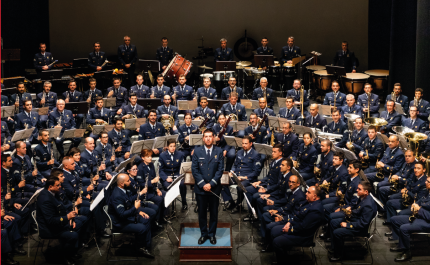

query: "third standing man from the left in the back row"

left=117, top=36, right=138, bottom=87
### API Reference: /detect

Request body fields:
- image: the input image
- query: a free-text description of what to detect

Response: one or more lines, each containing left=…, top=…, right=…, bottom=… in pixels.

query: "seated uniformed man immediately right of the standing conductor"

left=229, top=136, right=262, bottom=213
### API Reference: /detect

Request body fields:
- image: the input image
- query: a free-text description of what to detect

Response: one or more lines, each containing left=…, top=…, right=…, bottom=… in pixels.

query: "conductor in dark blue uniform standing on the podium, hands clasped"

left=192, top=129, right=224, bottom=245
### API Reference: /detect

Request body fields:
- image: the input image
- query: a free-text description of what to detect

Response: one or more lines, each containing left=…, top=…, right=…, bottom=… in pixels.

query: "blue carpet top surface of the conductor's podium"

left=179, top=227, right=231, bottom=247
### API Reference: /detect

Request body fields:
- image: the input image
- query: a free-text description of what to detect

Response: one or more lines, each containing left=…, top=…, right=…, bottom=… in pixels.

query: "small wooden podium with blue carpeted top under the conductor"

left=179, top=223, right=233, bottom=262
